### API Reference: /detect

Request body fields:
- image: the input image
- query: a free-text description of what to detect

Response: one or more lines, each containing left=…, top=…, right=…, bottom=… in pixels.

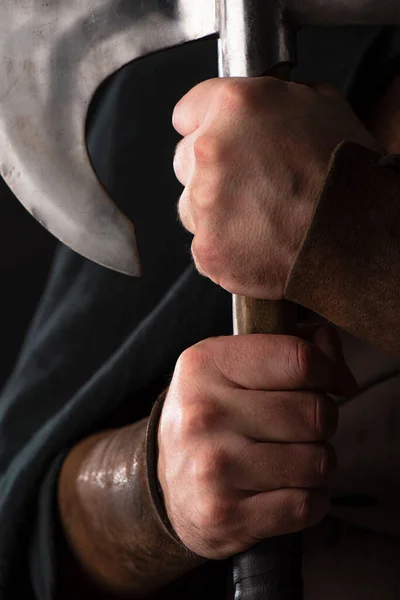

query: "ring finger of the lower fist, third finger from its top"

left=223, top=437, right=337, bottom=492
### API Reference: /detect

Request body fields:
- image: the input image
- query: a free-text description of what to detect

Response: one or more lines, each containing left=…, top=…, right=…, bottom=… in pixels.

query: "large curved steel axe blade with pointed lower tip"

left=0, top=0, right=217, bottom=275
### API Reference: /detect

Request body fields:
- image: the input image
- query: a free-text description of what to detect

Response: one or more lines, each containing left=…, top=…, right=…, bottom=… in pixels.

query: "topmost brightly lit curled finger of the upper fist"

left=172, top=79, right=221, bottom=136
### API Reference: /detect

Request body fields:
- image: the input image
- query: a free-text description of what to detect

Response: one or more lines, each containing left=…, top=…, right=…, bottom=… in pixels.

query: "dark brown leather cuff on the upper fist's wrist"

left=285, top=142, right=400, bottom=354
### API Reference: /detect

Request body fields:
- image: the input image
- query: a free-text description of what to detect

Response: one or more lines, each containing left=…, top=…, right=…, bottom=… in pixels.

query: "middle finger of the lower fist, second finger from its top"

left=225, top=390, right=338, bottom=443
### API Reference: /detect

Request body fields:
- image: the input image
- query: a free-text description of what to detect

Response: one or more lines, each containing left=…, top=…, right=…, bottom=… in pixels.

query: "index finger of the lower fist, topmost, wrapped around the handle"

left=203, top=334, right=336, bottom=393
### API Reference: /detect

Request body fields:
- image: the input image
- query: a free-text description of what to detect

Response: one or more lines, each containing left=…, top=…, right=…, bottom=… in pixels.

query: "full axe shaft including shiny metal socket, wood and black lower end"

left=219, top=0, right=303, bottom=600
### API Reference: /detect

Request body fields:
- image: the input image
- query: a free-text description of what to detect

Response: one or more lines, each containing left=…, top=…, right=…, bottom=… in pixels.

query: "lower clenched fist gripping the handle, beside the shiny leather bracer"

left=158, top=326, right=355, bottom=559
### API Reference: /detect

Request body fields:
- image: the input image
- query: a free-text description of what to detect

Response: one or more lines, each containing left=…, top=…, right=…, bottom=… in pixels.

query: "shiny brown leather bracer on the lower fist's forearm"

left=57, top=398, right=217, bottom=599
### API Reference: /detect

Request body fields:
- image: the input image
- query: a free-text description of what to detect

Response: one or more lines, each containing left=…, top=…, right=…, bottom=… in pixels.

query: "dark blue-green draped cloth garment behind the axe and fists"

left=0, top=28, right=400, bottom=600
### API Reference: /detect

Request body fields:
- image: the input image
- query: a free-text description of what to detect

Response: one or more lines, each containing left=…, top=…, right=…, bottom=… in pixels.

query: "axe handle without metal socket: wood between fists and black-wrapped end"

left=233, top=65, right=303, bottom=600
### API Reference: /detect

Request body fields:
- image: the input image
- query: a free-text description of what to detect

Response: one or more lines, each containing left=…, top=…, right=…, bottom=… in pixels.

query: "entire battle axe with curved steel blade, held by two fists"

left=0, top=0, right=400, bottom=600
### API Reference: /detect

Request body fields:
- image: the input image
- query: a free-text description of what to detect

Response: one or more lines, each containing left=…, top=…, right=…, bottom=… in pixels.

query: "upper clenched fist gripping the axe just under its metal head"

left=174, top=77, right=377, bottom=300
